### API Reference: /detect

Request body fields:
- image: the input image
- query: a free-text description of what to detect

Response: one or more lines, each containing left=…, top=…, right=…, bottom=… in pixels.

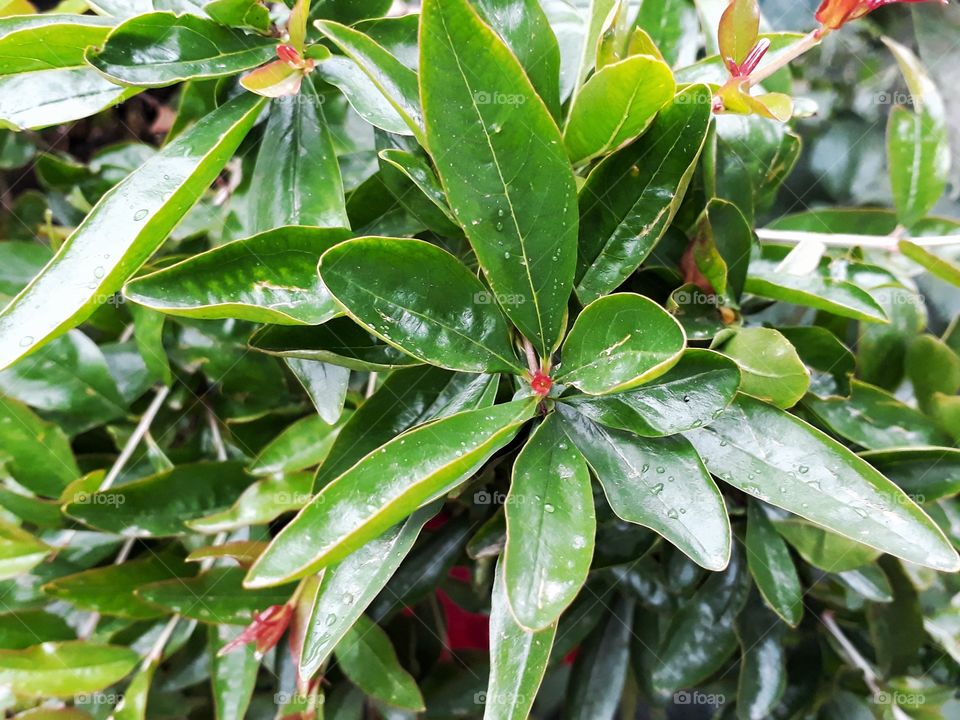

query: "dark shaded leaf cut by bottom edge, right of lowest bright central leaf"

left=563, top=596, right=634, bottom=720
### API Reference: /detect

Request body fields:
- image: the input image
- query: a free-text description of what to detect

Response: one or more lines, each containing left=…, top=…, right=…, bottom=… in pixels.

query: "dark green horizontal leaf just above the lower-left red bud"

left=137, top=567, right=294, bottom=625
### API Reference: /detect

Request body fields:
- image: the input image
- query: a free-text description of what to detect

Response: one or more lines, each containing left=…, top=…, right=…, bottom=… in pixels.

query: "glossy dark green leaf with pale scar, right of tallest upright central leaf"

left=576, top=85, right=712, bottom=303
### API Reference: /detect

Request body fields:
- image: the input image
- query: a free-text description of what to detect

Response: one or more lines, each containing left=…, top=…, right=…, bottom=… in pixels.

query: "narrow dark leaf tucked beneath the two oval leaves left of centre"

left=250, top=318, right=420, bottom=372
